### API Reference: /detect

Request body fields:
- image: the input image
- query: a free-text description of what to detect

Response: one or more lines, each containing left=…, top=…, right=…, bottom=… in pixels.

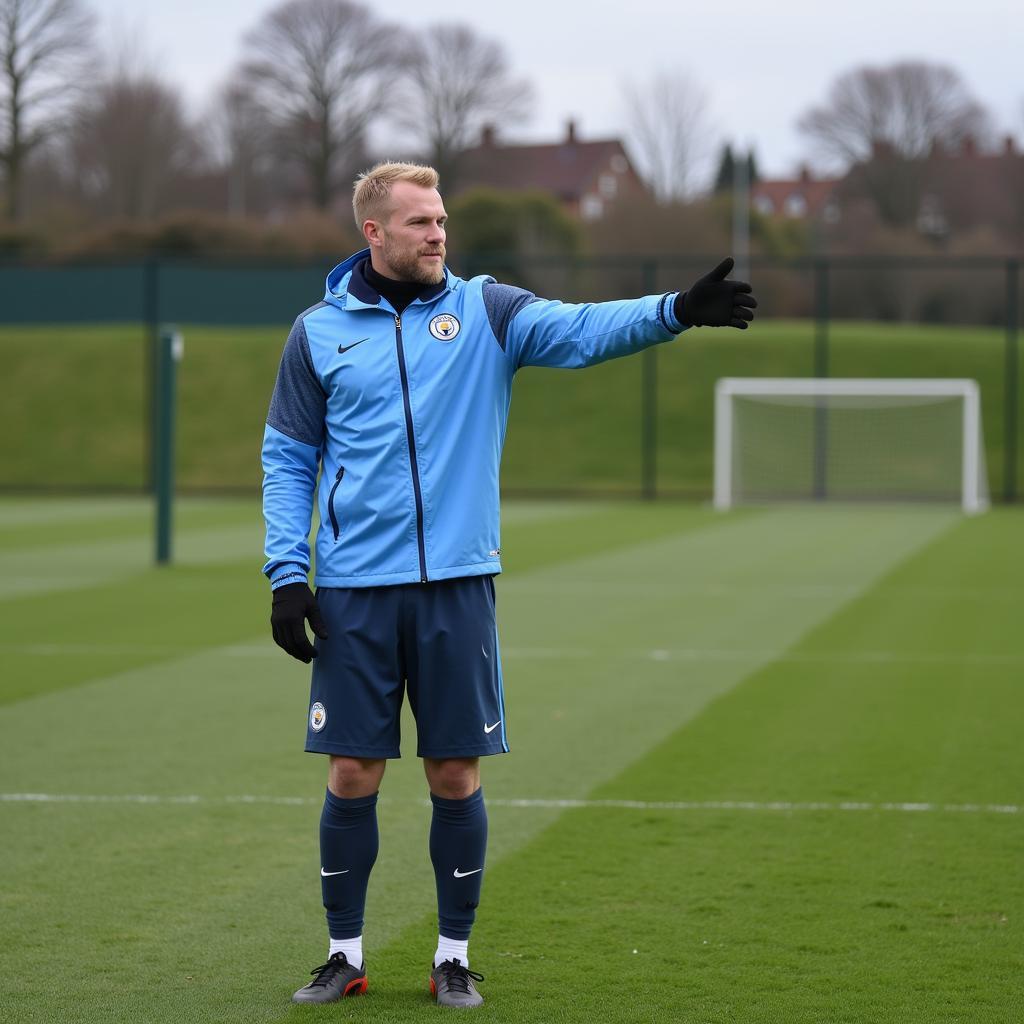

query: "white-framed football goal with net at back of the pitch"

left=715, top=377, right=988, bottom=514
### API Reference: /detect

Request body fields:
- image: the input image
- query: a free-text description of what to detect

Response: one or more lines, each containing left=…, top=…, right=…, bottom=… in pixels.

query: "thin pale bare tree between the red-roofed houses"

left=623, top=71, right=717, bottom=203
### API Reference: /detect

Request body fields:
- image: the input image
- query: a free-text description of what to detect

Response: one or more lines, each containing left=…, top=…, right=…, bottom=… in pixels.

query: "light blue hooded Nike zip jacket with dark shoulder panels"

left=263, top=250, right=683, bottom=588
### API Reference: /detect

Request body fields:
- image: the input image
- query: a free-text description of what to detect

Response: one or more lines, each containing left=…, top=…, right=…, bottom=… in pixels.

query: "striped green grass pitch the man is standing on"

left=0, top=500, right=1024, bottom=1024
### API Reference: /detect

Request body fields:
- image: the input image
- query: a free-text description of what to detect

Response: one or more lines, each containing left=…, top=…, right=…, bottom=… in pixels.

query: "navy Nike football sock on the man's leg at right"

left=430, top=790, right=487, bottom=939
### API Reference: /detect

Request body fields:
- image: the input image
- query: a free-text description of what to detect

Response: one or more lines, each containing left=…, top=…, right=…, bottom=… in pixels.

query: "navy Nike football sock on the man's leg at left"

left=321, top=790, right=378, bottom=939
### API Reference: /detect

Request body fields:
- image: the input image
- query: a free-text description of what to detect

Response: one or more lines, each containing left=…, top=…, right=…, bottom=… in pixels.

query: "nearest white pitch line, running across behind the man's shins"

left=0, top=793, right=1022, bottom=814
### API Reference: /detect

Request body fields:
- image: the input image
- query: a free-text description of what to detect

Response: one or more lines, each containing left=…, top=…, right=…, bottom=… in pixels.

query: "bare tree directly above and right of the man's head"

left=395, top=25, right=532, bottom=190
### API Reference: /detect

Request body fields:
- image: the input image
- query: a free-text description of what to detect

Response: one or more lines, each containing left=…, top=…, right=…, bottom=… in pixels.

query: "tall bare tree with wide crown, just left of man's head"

left=239, top=0, right=404, bottom=208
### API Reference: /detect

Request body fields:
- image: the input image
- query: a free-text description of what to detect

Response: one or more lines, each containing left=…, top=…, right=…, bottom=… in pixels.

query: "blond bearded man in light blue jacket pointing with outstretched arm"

left=263, top=164, right=757, bottom=1007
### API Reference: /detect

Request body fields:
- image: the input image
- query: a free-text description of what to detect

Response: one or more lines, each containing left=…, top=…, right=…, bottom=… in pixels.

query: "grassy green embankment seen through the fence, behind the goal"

left=0, top=321, right=1024, bottom=497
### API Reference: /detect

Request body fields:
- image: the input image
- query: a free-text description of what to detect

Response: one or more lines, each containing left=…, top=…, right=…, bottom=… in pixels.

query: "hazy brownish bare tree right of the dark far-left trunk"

left=70, top=72, right=201, bottom=220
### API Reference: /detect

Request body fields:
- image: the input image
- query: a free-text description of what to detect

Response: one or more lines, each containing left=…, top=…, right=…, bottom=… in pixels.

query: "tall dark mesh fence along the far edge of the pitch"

left=0, top=254, right=1021, bottom=501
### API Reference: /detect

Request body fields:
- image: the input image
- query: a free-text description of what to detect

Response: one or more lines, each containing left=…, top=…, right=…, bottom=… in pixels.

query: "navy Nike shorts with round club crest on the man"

left=306, top=575, right=509, bottom=758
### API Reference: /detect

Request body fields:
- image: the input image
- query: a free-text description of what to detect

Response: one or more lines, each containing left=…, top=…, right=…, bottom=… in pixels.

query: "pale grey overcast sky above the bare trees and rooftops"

left=85, top=0, right=1024, bottom=177
